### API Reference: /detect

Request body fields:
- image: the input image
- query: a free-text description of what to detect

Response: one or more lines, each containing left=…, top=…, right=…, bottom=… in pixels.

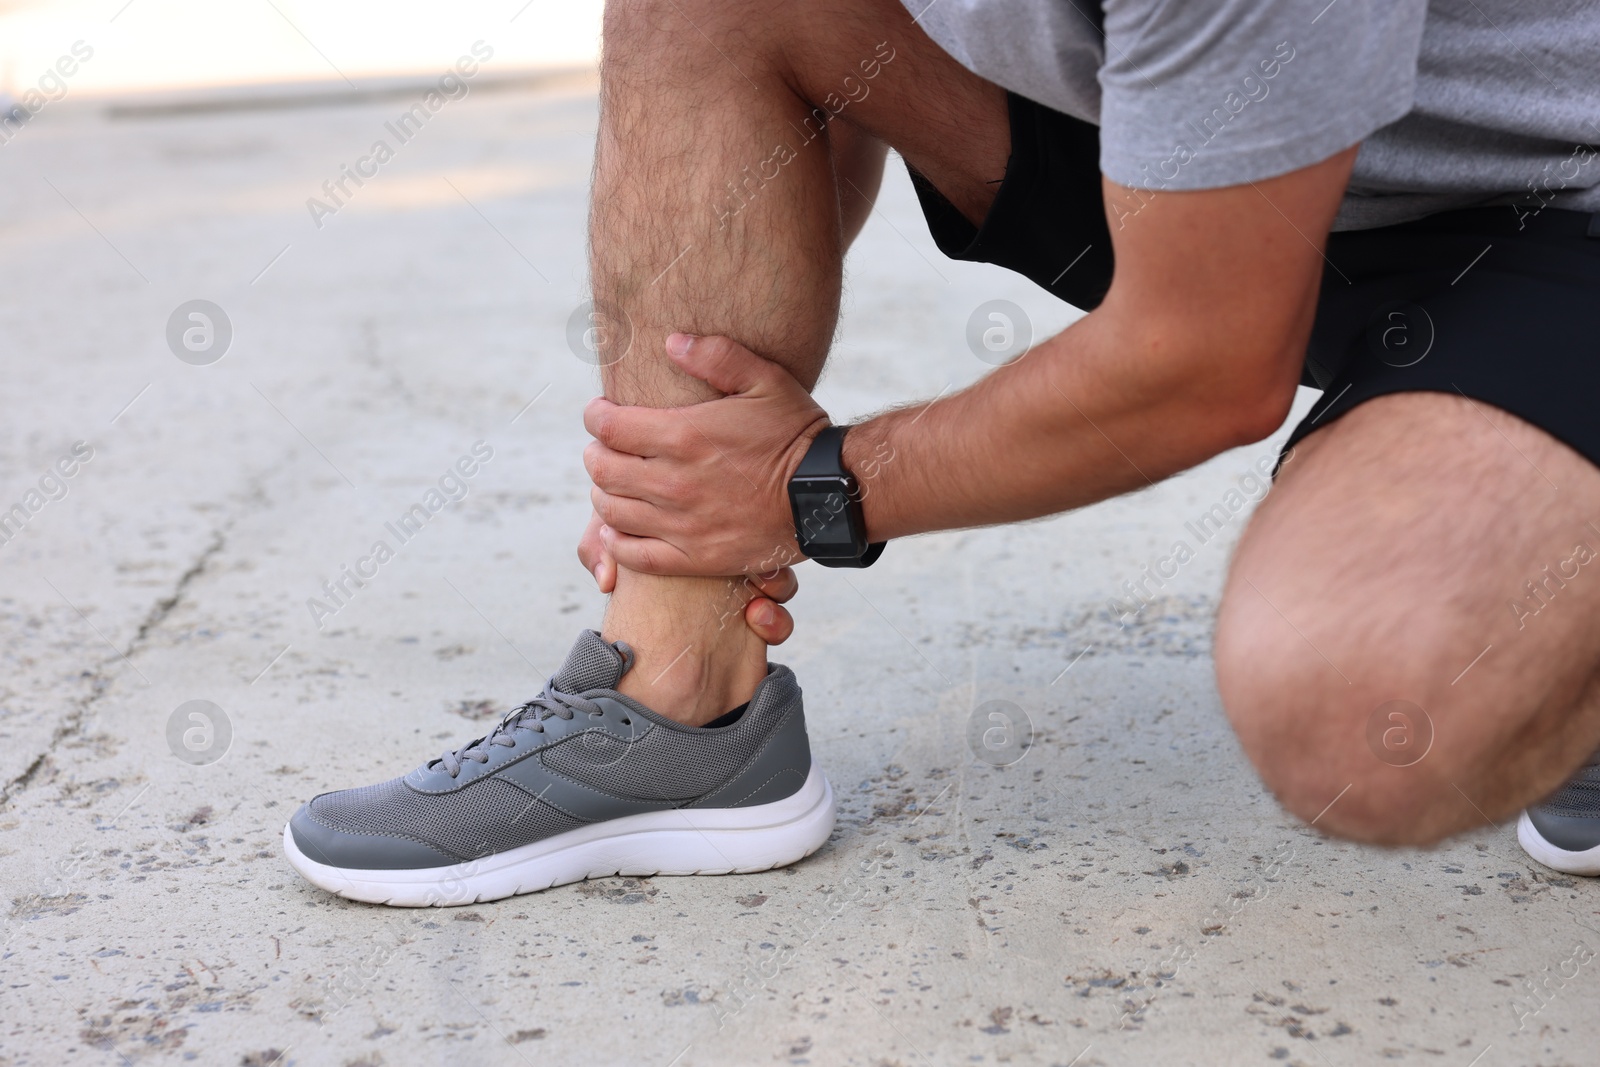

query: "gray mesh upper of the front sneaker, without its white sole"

left=290, top=630, right=810, bottom=869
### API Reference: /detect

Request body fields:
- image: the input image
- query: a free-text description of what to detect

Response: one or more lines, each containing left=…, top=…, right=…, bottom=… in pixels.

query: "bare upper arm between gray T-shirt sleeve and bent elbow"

left=1096, top=146, right=1357, bottom=432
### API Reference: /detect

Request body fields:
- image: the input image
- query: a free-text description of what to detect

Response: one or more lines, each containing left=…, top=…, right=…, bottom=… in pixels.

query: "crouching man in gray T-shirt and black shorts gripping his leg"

left=285, top=0, right=1600, bottom=904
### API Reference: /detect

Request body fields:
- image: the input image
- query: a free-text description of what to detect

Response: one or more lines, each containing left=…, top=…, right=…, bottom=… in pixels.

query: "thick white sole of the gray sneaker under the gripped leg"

left=283, top=763, right=834, bottom=907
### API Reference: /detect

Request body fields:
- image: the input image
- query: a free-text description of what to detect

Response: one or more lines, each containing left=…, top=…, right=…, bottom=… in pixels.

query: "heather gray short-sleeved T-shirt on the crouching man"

left=904, top=0, right=1600, bottom=230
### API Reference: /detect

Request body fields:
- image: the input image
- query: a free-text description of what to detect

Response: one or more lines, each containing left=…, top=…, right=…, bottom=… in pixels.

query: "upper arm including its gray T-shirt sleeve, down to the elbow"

left=1098, top=0, right=1429, bottom=429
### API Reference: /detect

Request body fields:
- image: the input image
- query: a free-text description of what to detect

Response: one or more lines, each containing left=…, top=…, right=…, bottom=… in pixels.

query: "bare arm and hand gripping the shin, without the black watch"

left=584, top=160, right=1357, bottom=574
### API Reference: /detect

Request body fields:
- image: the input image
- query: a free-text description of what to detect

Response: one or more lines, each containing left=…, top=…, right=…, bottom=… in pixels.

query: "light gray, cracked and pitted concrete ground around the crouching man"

left=0, top=70, right=1600, bottom=1067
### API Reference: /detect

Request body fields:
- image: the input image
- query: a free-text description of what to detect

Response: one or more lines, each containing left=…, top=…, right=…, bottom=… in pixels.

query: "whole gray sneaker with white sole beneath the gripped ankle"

left=283, top=630, right=834, bottom=907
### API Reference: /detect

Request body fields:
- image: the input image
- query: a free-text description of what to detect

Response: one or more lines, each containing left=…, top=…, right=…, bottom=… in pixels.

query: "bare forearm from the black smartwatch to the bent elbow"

left=845, top=306, right=1294, bottom=541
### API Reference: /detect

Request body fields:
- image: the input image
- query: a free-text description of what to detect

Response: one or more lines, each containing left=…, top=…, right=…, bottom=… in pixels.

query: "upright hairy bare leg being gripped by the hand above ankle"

left=590, top=0, right=1010, bottom=723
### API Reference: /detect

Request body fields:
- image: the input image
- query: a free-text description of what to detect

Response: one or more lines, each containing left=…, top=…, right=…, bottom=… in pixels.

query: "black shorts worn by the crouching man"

left=912, top=94, right=1600, bottom=466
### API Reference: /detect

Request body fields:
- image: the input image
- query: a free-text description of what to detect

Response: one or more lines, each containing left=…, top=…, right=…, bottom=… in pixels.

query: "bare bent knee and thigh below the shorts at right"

left=1216, top=392, right=1600, bottom=840
